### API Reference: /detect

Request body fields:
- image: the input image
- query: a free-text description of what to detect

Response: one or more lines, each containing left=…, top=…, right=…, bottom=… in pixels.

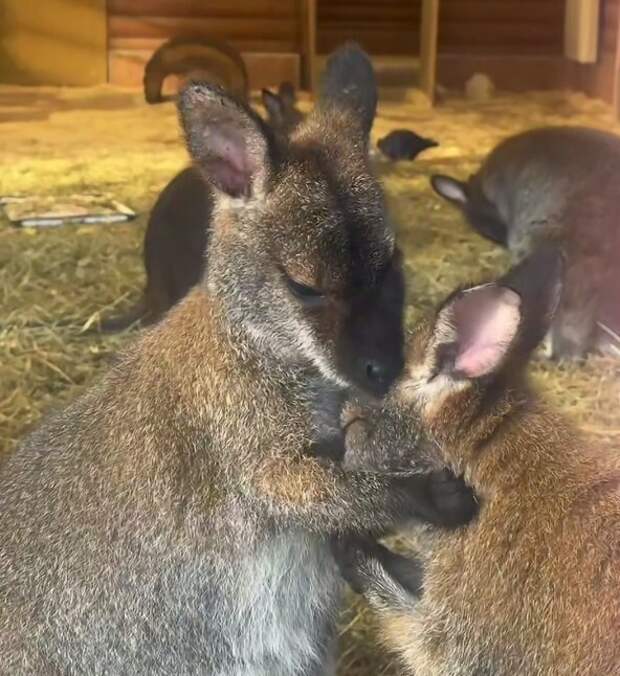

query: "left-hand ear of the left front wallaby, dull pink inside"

left=178, top=82, right=270, bottom=197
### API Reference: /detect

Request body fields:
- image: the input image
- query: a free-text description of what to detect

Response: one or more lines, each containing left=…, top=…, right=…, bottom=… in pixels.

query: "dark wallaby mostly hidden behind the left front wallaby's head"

left=101, top=82, right=304, bottom=332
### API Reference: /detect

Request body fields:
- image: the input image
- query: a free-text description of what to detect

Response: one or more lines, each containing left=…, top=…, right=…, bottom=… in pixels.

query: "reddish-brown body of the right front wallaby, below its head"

left=392, top=408, right=620, bottom=676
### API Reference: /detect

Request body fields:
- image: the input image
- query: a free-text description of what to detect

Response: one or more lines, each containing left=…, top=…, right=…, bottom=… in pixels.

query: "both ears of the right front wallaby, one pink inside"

left=435, top=246, right=563, bottom=379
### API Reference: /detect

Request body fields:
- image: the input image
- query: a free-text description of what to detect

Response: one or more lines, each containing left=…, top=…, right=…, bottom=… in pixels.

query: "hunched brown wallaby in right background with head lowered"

left=431, top=127, right=620, bottom=358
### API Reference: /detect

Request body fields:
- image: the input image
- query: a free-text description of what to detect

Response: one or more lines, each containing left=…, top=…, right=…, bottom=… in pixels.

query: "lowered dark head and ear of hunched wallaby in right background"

left=431, top=174, right=508, bottom=246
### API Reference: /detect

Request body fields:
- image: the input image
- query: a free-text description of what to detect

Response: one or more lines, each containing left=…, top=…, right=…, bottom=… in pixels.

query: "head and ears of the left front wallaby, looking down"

left=180, top=46, right=403, bottom=393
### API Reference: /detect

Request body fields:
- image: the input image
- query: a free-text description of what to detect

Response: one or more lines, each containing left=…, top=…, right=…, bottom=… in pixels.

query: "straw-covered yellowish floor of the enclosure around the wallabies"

left=0, top=87, right=620, bottom=675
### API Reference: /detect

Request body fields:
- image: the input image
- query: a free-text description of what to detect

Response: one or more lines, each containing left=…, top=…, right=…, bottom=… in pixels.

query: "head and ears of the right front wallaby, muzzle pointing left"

left=344, top=246, right=563, bottom=473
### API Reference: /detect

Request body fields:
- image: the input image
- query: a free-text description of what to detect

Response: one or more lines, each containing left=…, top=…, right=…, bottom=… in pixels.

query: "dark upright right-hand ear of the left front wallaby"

left=319, top=42, right=378, bottom=136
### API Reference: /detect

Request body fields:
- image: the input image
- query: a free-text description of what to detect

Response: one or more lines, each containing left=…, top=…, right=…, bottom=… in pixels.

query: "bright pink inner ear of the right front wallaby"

left=453, top=286, right=521, bottom=378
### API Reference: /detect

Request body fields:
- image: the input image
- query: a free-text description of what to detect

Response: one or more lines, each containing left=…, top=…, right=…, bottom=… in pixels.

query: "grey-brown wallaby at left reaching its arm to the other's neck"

left=0, top=46, right=471, bottom=676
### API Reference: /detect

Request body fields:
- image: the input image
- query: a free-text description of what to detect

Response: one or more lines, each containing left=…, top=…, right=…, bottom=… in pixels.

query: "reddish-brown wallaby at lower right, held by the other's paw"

left=336, top=248, right=620, bottom=676
